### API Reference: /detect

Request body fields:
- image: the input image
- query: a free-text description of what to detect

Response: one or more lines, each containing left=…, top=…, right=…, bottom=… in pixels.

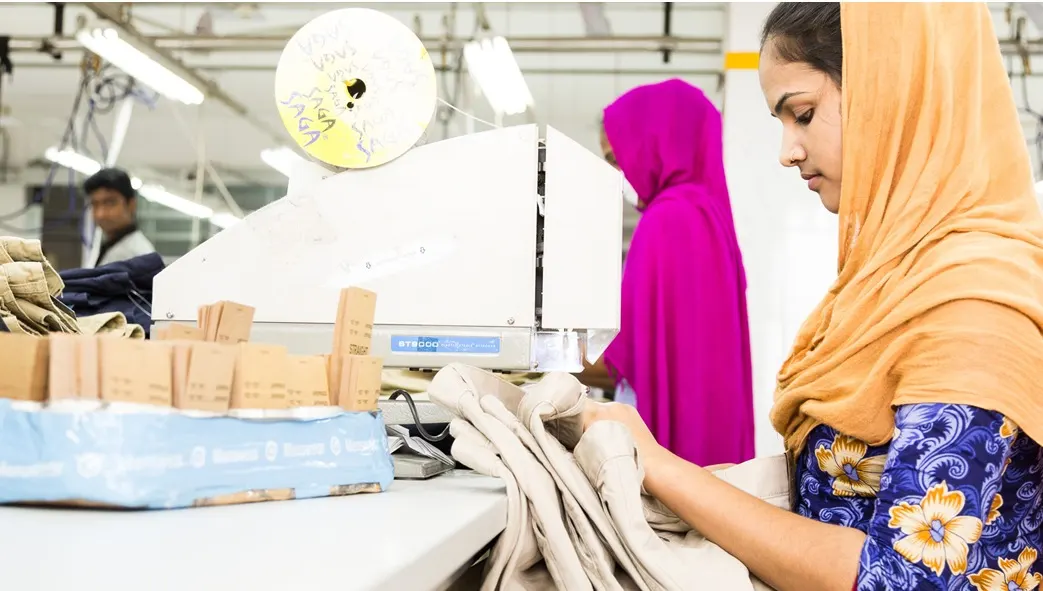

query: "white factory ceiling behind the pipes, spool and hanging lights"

left=0, top=2, right=1043, bottom=224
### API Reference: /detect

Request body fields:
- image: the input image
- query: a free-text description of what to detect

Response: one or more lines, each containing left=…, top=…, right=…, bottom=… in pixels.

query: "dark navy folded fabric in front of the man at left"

left=58, top=252, right=166, bottom=337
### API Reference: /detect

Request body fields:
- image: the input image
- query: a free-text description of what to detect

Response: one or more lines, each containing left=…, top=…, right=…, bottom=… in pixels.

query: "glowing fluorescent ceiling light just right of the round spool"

left=463, top=36, right=533, bottom=115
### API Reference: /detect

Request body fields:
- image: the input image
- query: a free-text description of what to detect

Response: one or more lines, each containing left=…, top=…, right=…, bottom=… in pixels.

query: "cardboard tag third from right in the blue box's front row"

left=232, top=343, right=290, bottom=409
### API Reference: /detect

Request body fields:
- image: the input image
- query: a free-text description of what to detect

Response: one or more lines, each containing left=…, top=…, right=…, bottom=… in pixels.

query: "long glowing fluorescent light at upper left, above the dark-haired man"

left=76, top=28, right=204, bottom=104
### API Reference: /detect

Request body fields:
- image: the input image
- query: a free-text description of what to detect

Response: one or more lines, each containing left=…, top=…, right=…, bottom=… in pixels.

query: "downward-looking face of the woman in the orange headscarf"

left=760, top=42, right=844, bottom=214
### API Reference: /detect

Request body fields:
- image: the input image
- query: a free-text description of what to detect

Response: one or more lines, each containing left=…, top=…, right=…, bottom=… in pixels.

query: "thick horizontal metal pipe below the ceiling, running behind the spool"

left=10, top=35, right=725, bottom=54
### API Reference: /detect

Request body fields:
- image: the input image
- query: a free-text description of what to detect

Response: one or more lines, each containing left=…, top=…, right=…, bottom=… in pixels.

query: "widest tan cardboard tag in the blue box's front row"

left=100, top=339, right=173, bottom=407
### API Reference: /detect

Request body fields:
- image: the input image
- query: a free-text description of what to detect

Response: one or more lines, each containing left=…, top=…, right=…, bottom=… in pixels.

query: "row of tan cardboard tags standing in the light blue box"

left=0, top=288, right=383, bottom=418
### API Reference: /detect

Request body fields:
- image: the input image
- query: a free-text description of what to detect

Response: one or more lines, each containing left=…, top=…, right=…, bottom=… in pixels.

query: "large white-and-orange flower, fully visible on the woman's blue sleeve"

left=888, top=483, right=981, bottom=575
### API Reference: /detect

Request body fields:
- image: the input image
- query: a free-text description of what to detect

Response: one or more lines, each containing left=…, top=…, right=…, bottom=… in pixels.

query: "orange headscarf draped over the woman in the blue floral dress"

left=772, top=2, right=1043, bottom=453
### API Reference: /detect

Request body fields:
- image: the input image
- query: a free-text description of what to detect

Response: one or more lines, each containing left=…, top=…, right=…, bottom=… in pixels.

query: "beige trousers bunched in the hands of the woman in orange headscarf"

left=429, top=364, right=790, bottom=591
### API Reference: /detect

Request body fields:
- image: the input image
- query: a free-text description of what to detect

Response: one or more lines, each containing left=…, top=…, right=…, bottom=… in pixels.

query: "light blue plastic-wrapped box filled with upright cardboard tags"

left=0, top=288, right=392, bottom=507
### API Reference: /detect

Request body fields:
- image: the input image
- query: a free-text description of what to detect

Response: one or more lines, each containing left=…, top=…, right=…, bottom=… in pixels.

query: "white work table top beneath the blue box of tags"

left=0, top=472, right=507, bottom=591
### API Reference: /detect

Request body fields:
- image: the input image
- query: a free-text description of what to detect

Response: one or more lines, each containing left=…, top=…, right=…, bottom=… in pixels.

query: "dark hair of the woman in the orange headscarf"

left=760, top=2, right=844, bottom=87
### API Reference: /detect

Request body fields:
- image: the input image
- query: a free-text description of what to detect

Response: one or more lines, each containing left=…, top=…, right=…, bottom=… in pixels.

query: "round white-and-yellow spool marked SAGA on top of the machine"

left=275, top=8, right=437, bottom=169
